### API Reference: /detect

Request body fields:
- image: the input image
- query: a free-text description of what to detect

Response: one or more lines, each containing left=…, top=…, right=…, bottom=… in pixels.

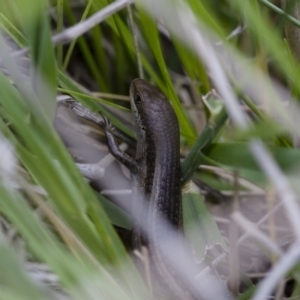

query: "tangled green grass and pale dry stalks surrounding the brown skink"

left=0, top=0, right=300, bottom=300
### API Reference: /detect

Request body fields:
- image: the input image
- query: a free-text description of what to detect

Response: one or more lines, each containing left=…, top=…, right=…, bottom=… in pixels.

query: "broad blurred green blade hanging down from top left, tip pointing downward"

left=14, top=0, right=57, bottom=122
